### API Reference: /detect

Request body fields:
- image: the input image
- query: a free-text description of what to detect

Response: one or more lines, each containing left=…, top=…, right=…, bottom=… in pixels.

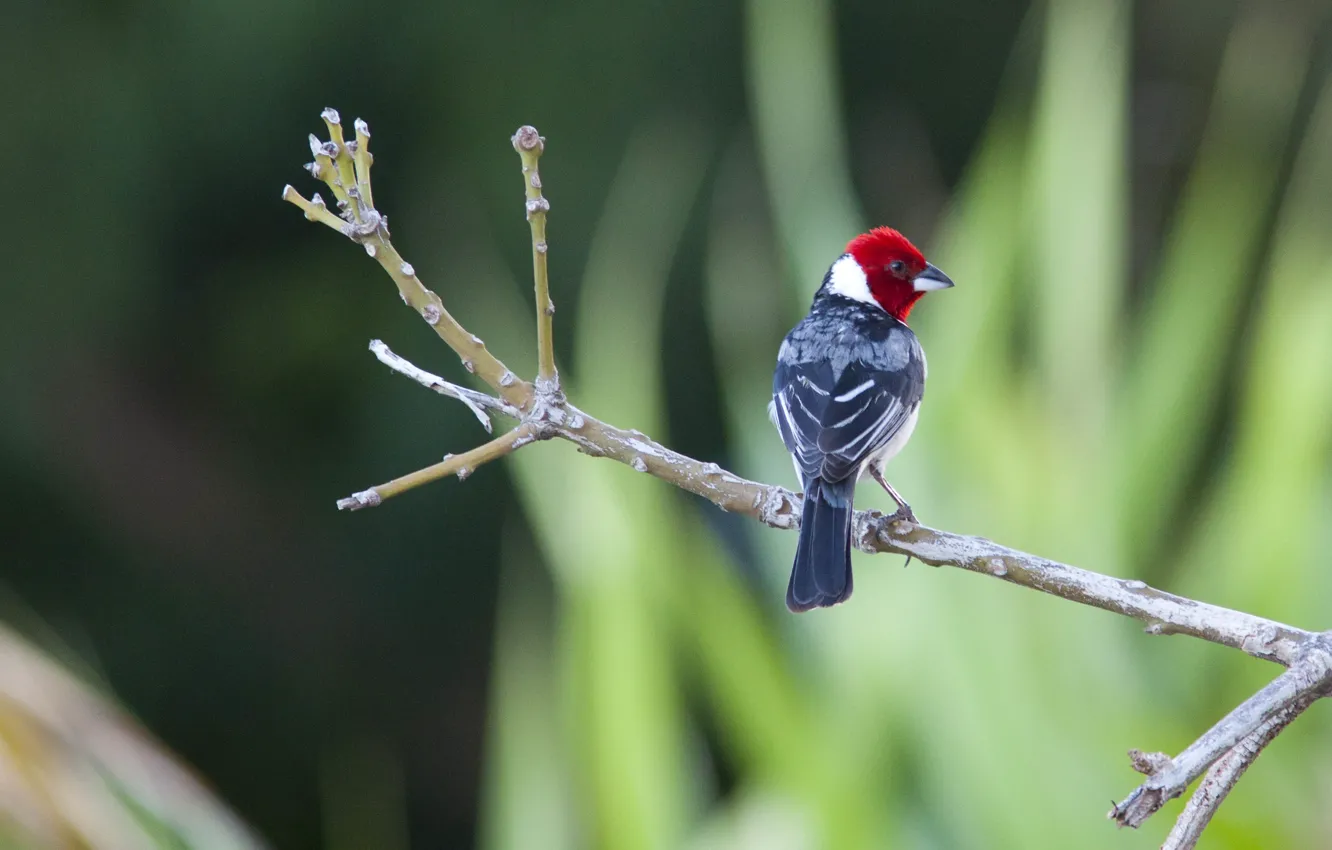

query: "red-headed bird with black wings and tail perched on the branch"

left=769, top=226, right=954, bottom=613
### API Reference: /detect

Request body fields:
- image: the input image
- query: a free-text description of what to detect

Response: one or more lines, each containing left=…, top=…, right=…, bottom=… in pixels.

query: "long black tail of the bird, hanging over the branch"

left=786, top=477, right=855, bottom=612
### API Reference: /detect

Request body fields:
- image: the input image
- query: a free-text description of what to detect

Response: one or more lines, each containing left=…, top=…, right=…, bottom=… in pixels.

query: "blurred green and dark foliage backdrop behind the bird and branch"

left=0, top=0, right=1332, bottom=850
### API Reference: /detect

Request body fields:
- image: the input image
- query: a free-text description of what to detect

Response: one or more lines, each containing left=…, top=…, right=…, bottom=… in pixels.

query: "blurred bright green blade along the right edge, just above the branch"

left=1187, top=78, right=1332, bottom=628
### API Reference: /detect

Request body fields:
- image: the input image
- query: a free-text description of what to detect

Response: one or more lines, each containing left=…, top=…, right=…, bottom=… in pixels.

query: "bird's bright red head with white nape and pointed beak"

left=829, top=228, right=952, bottom=321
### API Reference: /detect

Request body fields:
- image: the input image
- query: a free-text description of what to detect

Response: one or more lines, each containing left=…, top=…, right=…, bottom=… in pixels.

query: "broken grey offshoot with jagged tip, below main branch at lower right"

left=1107, top=634, right=1332, bottom=827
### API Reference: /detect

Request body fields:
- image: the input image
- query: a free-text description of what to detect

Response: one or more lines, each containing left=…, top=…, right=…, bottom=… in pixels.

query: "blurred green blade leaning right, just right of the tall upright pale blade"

left=1116, top=11, right=1309, bottom=560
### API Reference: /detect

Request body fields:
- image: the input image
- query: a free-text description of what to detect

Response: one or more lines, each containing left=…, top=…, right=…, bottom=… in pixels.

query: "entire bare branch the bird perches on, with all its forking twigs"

left=282, top=109, right=1332, bottom=850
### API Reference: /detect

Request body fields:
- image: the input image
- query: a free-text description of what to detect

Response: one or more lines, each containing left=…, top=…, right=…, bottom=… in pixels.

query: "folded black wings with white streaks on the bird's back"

left=773, top=331, right=924, bottom=481
